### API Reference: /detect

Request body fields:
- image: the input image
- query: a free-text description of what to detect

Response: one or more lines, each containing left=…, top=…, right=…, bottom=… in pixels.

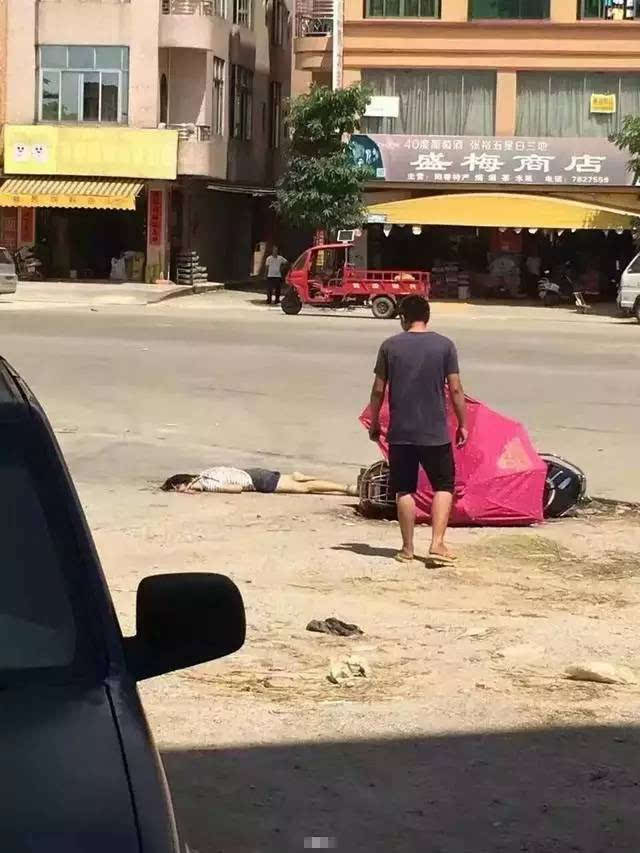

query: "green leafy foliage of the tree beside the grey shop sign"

left=274, top=85, right=370, bottom=231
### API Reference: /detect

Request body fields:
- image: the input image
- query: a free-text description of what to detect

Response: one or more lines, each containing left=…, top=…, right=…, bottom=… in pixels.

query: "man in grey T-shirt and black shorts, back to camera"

left=369, top=296, right=468, bottom=563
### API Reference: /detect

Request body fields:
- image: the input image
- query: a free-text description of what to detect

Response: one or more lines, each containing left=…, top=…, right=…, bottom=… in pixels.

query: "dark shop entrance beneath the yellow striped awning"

left=36, top=193, right=146, bottom=281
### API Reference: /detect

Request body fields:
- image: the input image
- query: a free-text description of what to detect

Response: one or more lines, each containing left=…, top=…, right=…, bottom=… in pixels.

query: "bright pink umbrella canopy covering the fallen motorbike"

left=360, top=397, right=547, bottom=526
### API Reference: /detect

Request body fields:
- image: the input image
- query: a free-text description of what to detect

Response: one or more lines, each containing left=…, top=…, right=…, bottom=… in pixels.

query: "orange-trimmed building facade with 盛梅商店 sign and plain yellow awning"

left=294, top=0, right=640, bottom=296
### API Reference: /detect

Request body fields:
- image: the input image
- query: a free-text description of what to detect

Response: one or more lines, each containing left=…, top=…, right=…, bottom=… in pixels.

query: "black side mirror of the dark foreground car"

left=124, top=573, right=246, bottom=681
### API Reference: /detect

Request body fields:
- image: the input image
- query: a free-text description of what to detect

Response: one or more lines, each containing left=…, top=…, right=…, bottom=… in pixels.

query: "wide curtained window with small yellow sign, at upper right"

left=516, top=71, right=640, bottom=137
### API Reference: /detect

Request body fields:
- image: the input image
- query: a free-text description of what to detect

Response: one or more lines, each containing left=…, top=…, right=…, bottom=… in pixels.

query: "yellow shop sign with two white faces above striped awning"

left=4, top=124, right=178, bottom=180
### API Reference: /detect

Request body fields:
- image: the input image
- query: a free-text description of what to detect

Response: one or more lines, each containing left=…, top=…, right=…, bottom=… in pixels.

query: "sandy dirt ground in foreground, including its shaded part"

left=83, top=480, right=640, bottom=853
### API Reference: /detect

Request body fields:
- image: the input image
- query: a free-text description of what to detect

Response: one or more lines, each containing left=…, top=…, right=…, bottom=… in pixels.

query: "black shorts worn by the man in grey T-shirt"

left=389, top=444, right=456, bottom=495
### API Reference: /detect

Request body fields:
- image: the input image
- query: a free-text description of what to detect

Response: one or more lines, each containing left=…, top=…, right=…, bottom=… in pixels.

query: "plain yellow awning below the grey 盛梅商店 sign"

left=367, top=193, right=638, bottom=229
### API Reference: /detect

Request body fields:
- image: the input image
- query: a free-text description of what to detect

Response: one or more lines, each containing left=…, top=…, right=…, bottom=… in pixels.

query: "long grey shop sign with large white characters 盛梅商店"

left=349, top=134, right=634, bottom=188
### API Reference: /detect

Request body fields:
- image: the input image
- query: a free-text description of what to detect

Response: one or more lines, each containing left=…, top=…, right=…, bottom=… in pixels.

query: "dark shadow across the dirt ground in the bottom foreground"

left=163, top=724, right=640, bottom=853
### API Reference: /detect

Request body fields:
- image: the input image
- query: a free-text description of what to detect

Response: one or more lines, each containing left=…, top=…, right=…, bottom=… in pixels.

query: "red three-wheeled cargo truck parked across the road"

left=281, top=243, right=430, bottom=320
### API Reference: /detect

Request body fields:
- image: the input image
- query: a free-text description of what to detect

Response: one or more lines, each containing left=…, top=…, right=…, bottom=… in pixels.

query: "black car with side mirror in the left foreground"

left=0, top=359, right=245, bottom=853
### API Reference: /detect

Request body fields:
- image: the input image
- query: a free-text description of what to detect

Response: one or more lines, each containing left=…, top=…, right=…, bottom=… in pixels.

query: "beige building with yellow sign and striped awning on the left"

left=0, top=0, right=290, bottom=281
